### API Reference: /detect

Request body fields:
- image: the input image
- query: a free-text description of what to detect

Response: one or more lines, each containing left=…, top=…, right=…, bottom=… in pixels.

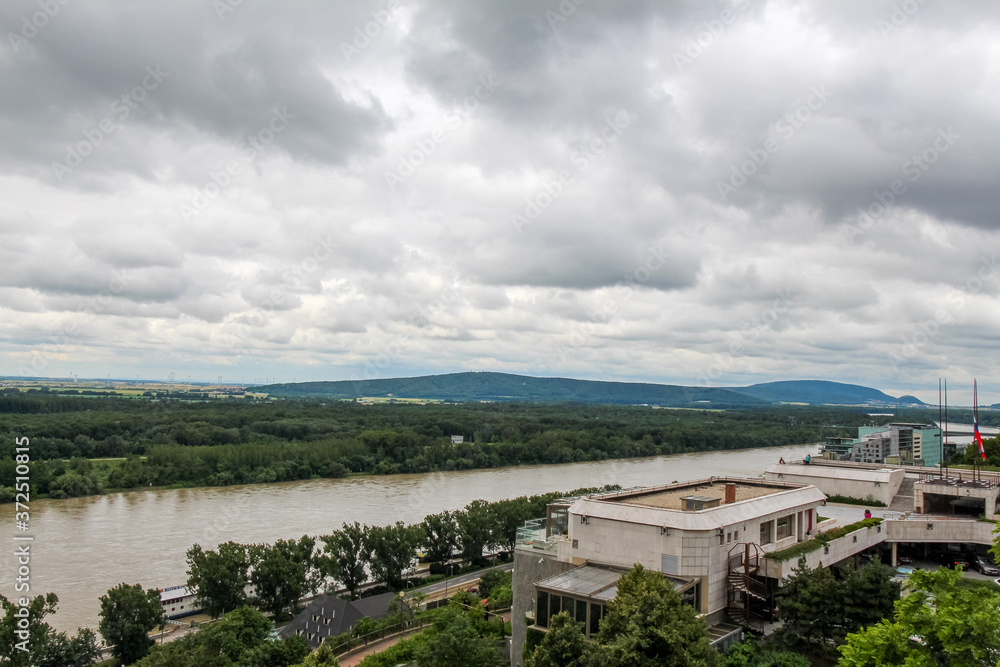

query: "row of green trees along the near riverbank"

left=186, top=486, right=620, bottom=618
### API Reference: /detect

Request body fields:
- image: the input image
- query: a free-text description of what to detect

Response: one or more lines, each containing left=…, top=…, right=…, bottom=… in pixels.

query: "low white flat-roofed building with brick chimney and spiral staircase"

left=511, top=477, right=827, bottom=660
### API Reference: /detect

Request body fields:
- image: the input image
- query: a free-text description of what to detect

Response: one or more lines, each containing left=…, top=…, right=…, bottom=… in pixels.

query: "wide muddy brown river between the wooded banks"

left=0, top=445, right=817, bottom=632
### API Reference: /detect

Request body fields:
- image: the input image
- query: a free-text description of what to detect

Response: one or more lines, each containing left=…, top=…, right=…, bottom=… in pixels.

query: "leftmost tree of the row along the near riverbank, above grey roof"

left=187, top=542, right=251, bottom=618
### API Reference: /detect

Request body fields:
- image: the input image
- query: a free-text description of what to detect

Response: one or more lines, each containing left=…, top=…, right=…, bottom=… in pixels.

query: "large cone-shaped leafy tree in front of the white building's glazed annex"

left=597, top=564, right=719, bottom=667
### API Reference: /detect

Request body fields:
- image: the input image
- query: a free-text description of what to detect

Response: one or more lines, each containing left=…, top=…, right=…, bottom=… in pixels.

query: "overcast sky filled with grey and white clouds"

left=0, top=0, right=1000, bottom=403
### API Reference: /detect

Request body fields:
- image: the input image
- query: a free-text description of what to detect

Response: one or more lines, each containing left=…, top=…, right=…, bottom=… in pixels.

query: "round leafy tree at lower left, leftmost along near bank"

left=98, top=583, right=166, bottom=665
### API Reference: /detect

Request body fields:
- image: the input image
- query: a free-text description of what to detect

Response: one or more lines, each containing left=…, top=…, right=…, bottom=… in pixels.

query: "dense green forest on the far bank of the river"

left=0, top=392, right=976, bottom=501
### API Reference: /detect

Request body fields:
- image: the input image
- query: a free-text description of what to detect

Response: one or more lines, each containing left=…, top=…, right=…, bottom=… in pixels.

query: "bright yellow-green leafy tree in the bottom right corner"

left=838, top=568, right=1000, bottom=667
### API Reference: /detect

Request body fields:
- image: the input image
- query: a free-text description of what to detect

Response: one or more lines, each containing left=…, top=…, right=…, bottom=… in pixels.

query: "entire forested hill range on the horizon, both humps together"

left=255, top=372, right=924, bottom=408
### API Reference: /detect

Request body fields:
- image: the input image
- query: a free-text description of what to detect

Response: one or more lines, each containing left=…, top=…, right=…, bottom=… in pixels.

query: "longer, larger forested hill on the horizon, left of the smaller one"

left=256, top=373, right=767, bottom=408
